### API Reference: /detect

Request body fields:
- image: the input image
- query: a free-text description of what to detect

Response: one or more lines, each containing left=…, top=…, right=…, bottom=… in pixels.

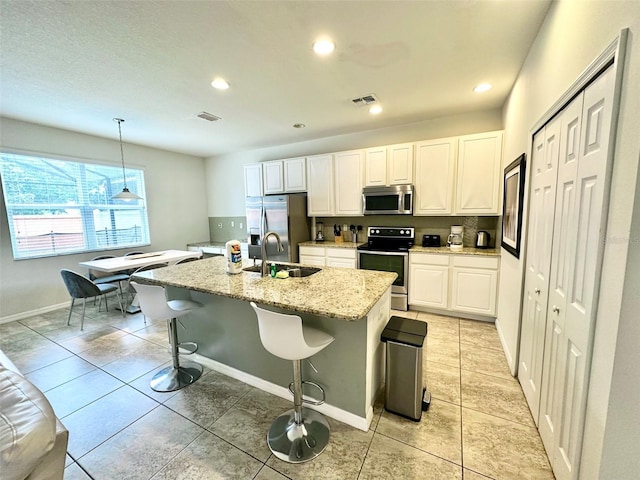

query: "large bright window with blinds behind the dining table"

left=0, top=152, right=150, bottom=259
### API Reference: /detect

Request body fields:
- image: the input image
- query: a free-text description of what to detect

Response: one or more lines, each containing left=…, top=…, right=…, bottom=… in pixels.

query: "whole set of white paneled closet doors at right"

left=518, top=66, right=615, bottom=479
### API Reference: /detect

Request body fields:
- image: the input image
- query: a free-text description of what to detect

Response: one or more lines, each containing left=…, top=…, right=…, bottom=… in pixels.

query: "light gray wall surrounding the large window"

left=0, top=118, right=209, bottom=322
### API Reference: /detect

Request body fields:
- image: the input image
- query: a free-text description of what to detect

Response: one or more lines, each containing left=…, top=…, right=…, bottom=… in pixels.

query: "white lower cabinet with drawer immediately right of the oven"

left=409, top=253, right=449, bottom=310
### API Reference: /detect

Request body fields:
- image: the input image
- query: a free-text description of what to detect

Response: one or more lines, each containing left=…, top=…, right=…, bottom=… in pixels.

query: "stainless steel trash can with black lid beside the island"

left=380, top=316, right=431, bottom=422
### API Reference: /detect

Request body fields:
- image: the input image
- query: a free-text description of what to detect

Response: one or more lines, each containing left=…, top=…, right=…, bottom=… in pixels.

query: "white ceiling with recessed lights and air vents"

left=0, top=0, right=550, bottom=157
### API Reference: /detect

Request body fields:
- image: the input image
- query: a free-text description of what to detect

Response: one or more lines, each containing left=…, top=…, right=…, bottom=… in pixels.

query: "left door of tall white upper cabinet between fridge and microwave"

left=307, top=154, right=334, bottom=217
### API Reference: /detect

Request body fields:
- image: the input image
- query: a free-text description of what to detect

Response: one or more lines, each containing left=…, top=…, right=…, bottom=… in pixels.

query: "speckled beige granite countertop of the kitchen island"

left=133, top=257, right=397, bottom=321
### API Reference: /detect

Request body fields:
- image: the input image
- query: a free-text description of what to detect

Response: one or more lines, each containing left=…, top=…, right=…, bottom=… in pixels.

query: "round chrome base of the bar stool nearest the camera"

left=267, top=408, right=331, bottom=463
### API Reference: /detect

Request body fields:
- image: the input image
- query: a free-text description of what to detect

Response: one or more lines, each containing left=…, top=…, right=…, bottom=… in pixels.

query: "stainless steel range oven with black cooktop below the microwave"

left=358, top=227, right=415, bottom=311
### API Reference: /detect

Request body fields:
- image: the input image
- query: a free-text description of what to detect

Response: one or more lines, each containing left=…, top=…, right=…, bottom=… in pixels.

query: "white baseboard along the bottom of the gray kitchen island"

left=193, top=353, right=373, bottom=432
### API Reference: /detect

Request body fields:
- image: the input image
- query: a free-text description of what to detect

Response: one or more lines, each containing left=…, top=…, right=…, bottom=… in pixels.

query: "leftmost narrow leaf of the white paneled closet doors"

left=518, top=117, right=560, bottom=424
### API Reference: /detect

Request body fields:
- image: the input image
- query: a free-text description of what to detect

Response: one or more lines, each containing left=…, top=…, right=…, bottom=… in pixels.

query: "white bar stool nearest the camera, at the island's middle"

left=251, top=302, right=335, bottom=463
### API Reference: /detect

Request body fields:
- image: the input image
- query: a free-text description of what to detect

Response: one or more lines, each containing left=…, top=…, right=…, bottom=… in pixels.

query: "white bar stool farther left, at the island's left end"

left=131, top=282, right=203, bottom=392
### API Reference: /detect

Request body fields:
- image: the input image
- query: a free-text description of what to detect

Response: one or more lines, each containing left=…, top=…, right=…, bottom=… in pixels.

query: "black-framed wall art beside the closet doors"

left=501, top=153, right=526, bottom=258
